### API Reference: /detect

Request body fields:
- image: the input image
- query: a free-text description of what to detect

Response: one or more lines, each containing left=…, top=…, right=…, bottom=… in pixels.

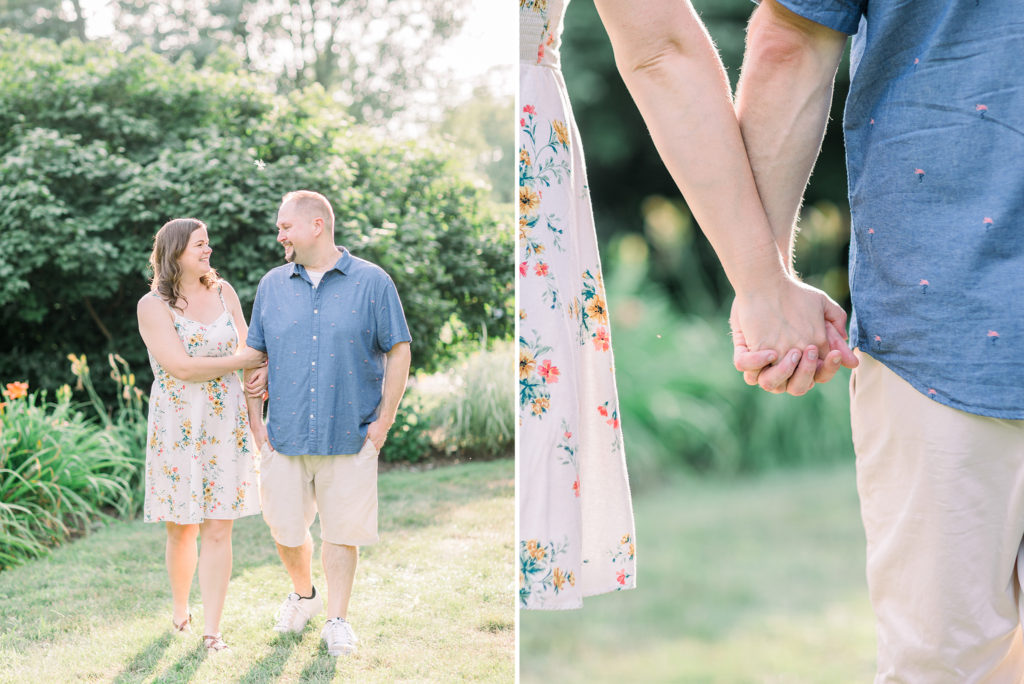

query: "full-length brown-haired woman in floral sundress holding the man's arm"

left=138, top=218, right=266, bottom=650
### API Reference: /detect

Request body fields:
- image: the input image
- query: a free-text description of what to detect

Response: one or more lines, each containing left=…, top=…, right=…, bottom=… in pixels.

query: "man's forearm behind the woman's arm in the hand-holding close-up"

left=736, top=0, right=846, bottom=270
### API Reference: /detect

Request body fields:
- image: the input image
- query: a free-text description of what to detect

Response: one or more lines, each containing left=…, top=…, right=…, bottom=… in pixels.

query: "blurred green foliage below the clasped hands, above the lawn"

left=607, top=239, right=853, bottom=484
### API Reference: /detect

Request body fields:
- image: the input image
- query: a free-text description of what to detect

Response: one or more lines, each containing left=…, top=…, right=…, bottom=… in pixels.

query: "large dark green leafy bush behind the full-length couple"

left=0, top=32, right=512, bottom=395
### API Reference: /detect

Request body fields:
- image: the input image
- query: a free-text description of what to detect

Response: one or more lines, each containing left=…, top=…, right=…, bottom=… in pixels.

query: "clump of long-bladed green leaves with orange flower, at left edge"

left=0, top=384, right=138, bottom=569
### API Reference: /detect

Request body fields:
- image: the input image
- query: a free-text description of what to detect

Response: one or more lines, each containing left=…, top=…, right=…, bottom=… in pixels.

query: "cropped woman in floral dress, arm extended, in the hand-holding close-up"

left=517, top=0, right=845, bottom=609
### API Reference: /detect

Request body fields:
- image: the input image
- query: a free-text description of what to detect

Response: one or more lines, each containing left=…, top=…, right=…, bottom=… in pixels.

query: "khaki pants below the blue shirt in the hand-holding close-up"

left=850, top=352, right=1024, bottom=684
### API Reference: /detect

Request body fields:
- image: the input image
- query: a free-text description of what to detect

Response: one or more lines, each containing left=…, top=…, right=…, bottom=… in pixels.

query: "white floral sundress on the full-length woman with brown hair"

left=143, top=286, right=260, bottom=524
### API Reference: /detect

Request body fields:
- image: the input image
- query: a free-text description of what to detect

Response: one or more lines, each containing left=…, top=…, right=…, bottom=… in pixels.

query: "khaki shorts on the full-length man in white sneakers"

left=259, top=439, right=379, bottom=547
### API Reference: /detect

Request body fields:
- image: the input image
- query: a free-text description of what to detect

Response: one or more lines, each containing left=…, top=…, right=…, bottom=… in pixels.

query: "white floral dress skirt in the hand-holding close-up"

left=518, top=0, right=636, bottom=609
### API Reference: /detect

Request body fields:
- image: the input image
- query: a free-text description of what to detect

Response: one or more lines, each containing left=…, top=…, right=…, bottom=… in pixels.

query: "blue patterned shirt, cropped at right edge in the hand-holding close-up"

left=779, top=0, right=1024, bottom=419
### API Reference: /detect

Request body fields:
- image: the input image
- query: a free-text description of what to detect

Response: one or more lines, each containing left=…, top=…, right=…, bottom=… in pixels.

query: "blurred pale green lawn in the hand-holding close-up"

left=519, top=465, right=874, bottom=684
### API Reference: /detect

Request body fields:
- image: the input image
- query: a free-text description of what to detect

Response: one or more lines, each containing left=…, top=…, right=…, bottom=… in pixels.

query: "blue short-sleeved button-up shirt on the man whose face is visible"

left=247, top=247, right=412, bottom=456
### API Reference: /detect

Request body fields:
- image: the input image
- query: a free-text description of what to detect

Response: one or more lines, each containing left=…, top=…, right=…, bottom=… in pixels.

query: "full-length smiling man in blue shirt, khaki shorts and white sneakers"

left=248, top=190, right=411, bottom=655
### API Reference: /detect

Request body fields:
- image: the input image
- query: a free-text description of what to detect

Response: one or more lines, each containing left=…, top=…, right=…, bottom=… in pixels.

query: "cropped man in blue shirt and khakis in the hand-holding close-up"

left=736, top=0, right=1024, bottom=684
